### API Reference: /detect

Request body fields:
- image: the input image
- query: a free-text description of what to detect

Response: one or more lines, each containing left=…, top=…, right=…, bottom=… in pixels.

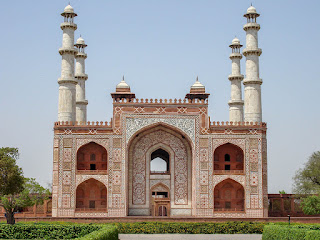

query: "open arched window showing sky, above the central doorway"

left=150, top=148, right=170, bottom=174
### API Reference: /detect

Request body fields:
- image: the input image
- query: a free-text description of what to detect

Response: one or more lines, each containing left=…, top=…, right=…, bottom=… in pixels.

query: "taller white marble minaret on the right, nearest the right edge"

left=243, top=6, right=262, bottom=122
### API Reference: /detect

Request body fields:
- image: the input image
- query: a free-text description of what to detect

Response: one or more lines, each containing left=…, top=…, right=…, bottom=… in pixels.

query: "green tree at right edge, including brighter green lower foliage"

left=293, top=151, right=320, bottom=215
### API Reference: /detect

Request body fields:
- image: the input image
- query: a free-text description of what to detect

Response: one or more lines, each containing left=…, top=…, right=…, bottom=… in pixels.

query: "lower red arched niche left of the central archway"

left=76, top=178, right=107, bottom=211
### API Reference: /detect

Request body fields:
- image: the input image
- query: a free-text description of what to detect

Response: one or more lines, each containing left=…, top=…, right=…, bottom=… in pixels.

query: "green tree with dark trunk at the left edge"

left=0, top=148, right=50, bottom=224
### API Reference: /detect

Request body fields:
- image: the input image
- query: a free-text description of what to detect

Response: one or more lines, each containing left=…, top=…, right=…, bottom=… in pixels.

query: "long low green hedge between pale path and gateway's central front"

left=117, top=222, right=265, bottom=234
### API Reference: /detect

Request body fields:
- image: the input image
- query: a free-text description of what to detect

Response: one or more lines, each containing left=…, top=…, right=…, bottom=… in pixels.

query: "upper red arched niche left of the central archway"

left=77, top=142, right=108, bottom=171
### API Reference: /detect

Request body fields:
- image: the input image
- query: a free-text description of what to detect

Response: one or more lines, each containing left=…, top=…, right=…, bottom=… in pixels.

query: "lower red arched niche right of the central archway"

left=214, top=178, right=245, bottom=212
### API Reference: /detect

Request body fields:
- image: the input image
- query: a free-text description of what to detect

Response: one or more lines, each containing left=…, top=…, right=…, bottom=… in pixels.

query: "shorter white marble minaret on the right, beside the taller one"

left=228, top=38, right=243, bottom=122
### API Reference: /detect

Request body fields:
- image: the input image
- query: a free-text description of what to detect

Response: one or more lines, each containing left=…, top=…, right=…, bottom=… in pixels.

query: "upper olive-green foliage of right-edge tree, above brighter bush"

left=293, top=151, right=320, bottom=194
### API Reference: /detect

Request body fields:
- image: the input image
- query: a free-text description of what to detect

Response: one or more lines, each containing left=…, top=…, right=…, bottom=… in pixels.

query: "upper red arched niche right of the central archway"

left=214, top=143, right=244, bottom=174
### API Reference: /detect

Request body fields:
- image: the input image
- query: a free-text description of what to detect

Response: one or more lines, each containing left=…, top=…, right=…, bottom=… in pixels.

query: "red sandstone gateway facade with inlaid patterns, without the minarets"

left=52, top=85, right=268, bottom=218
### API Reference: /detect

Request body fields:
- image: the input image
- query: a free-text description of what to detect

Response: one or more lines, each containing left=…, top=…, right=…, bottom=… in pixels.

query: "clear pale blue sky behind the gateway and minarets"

left=0, top=0, right=320, bottom=193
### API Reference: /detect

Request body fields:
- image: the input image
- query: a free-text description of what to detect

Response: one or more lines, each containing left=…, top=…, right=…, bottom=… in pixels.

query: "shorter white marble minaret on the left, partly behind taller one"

left=75, top=36, right=88, bottom=123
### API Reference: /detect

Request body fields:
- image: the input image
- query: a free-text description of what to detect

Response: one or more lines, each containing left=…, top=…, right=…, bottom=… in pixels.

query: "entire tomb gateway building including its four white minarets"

left=52, top=5, right=268, bottom=218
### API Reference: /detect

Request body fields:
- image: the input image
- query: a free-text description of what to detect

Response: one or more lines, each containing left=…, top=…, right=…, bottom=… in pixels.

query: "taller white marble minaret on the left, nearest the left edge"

left=58, top=5, right=77, bottom=122
